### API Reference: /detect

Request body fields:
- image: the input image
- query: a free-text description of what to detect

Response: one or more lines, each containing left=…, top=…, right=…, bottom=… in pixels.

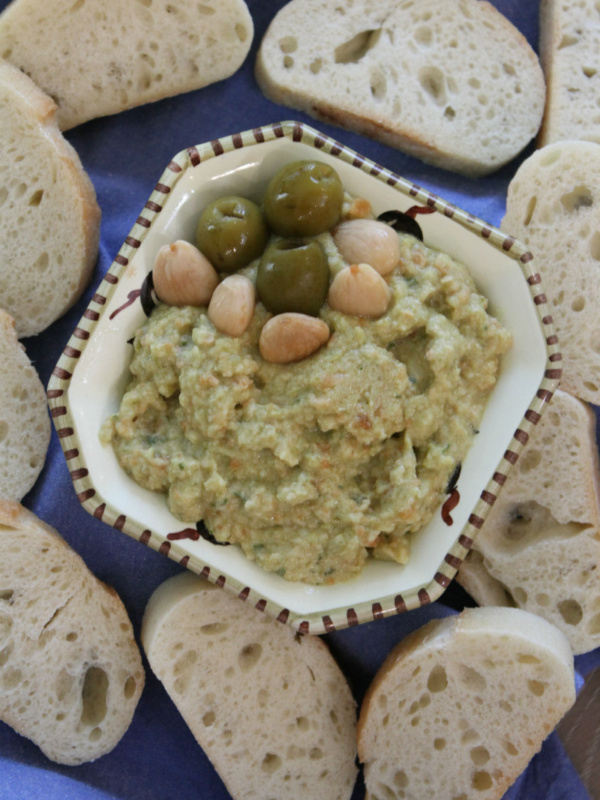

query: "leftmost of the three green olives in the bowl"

left=196, top=195, right=269, bottom=272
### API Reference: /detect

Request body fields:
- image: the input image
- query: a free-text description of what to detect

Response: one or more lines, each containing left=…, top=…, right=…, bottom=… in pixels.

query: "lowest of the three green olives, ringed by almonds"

left=256, top=239, right=329, bottom=317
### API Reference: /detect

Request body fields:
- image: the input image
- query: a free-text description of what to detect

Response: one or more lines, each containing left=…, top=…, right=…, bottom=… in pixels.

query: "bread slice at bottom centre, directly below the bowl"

left=142, top=572, right=357, bottom=800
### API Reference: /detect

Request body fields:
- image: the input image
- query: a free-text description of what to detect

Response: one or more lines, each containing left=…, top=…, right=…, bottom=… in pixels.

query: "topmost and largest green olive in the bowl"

left=264, top=161, right=344, bottom=236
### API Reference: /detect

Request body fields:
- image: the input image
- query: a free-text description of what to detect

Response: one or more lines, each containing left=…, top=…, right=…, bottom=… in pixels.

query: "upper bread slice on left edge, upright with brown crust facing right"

left=0, top=60, right=100, bottom=339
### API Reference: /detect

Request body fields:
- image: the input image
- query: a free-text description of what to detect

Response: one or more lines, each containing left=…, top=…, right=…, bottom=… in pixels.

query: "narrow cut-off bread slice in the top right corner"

left=538, top=0, right=600, bottom=147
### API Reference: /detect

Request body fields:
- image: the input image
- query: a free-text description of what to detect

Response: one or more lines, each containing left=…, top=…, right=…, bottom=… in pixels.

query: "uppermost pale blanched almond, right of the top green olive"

left=333, top=219, right=400, bottom=275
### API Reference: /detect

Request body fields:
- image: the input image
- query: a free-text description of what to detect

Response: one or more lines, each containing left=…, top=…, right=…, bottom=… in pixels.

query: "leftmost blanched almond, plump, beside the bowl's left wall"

left=152, top=239, right=219, bottom=306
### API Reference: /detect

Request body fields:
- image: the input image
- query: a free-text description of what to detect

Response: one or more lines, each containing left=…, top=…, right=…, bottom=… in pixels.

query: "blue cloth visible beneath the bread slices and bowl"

left=0, top=0, right=600, bottom=800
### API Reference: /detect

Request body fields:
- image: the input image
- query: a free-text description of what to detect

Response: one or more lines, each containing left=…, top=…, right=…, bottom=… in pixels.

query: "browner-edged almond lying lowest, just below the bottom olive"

left=258, top=311, right=329, bottom=364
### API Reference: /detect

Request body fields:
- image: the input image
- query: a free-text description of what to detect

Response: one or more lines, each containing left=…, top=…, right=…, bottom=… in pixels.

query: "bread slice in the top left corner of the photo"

left=0, top=0, right=254, bottom=130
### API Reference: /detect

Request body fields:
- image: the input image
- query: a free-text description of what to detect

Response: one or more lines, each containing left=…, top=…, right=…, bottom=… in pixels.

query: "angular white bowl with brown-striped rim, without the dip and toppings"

left=48, top=122, right=560, bottom=633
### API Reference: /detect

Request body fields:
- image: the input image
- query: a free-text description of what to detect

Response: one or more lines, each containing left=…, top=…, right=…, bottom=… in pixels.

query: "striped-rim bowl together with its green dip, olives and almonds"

left=49, top=122, right=558, bottom=633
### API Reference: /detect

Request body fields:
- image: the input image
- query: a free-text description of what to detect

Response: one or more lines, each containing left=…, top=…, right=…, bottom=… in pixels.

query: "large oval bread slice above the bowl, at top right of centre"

left=256, top=0, right=545, bottom=175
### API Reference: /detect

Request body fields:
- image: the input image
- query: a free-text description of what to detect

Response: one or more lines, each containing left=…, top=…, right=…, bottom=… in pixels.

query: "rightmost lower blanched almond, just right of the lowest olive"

left=327, top=264, right=391, bottom=318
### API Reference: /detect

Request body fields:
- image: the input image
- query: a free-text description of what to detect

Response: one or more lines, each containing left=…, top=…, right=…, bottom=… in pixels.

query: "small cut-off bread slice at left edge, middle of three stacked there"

left=0, top=309, right=50, bottom=500
